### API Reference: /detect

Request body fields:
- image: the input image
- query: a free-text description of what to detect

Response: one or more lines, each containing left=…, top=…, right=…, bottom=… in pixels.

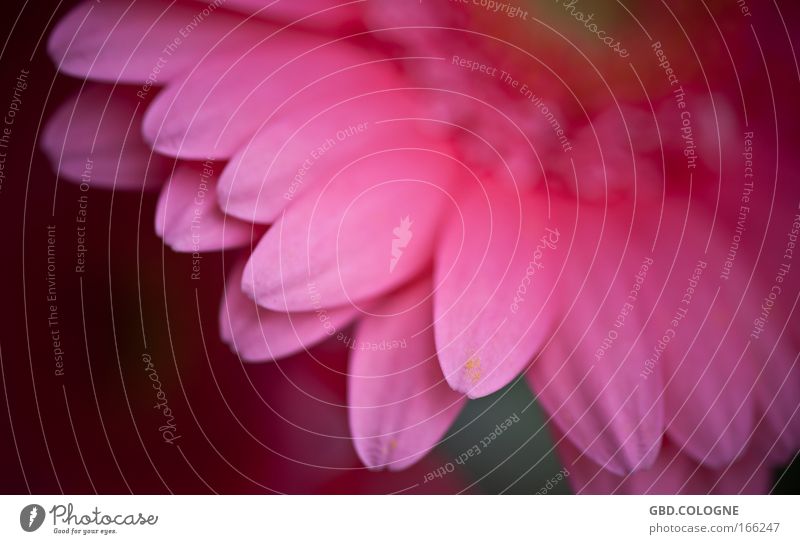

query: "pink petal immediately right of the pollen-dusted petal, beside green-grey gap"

left=527, top=199, right=664, bottom=474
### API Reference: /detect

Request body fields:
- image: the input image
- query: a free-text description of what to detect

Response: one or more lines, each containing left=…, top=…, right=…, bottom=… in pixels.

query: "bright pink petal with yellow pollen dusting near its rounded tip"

left=434, top=186, right=567, bottom=398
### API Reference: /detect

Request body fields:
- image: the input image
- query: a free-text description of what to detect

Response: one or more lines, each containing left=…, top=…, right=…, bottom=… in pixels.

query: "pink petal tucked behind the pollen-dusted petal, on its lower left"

left=348, top=281, right=464, bottom=470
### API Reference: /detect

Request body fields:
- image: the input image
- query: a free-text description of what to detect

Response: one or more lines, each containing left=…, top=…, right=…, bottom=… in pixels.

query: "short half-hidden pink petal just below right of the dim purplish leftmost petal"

left=156, top=161, right=255, bottom=252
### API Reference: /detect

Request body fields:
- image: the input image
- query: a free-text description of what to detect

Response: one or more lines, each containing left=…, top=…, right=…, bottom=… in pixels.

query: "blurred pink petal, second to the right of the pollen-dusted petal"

left=653, top=201, right=756, bottom=467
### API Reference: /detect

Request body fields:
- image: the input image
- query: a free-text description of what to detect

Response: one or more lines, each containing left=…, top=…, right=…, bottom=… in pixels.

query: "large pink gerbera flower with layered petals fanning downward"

left=44, top=0, right=800, bottom=493
